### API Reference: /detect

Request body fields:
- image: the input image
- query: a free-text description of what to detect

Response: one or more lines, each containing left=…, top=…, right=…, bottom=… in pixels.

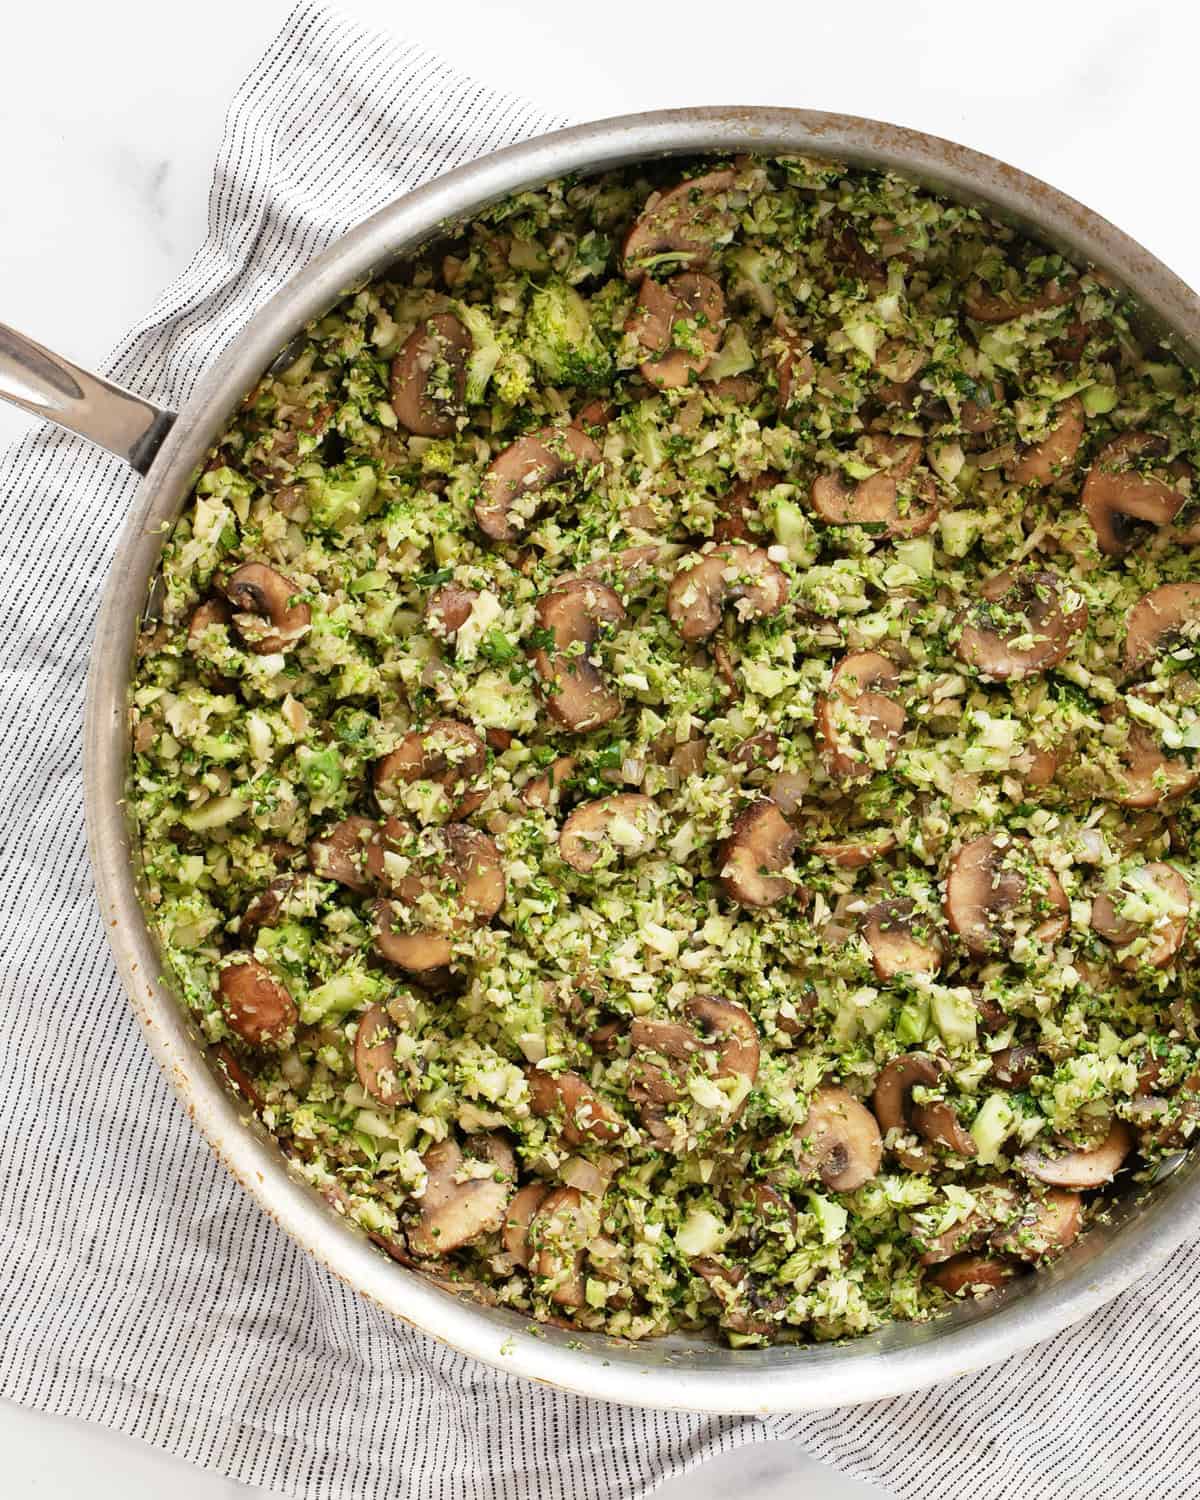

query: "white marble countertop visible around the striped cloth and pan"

left=0, top=0, right=1200, bottom=1500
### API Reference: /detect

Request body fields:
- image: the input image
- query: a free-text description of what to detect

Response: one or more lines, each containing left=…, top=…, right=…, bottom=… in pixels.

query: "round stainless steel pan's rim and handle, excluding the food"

left=0, top=108, right=1200, bottom=1412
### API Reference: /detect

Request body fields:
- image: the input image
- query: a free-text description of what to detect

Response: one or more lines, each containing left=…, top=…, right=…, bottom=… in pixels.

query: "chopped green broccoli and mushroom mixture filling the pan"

left=134, top=158, right=1200, bottom=1344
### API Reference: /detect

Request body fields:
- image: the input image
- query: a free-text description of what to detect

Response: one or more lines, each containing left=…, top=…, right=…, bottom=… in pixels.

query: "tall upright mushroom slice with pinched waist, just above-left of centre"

left=534, top=578, right=626, bottom=734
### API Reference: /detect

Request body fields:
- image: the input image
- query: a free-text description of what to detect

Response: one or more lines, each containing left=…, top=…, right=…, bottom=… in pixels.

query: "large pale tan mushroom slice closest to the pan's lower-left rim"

left=408, top=1136, right=516, bottom=1257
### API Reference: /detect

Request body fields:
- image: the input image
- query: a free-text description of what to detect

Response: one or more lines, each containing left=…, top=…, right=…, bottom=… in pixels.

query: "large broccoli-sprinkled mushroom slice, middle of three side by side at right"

left=945, top=834, right=1070, bottom=957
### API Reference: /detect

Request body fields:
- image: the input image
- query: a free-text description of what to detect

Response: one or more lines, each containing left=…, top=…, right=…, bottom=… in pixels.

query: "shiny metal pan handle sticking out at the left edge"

left=0, top=323, right=176, bottom=474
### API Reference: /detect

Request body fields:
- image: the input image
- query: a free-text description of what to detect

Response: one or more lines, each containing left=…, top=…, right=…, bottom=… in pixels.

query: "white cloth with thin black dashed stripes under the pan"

left=0, top=5, right=1200, bottom=1500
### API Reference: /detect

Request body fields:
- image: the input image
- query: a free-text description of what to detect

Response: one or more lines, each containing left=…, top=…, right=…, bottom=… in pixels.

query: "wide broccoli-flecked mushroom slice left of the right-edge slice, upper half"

left=954, top=569, right=1088, bottom=683
